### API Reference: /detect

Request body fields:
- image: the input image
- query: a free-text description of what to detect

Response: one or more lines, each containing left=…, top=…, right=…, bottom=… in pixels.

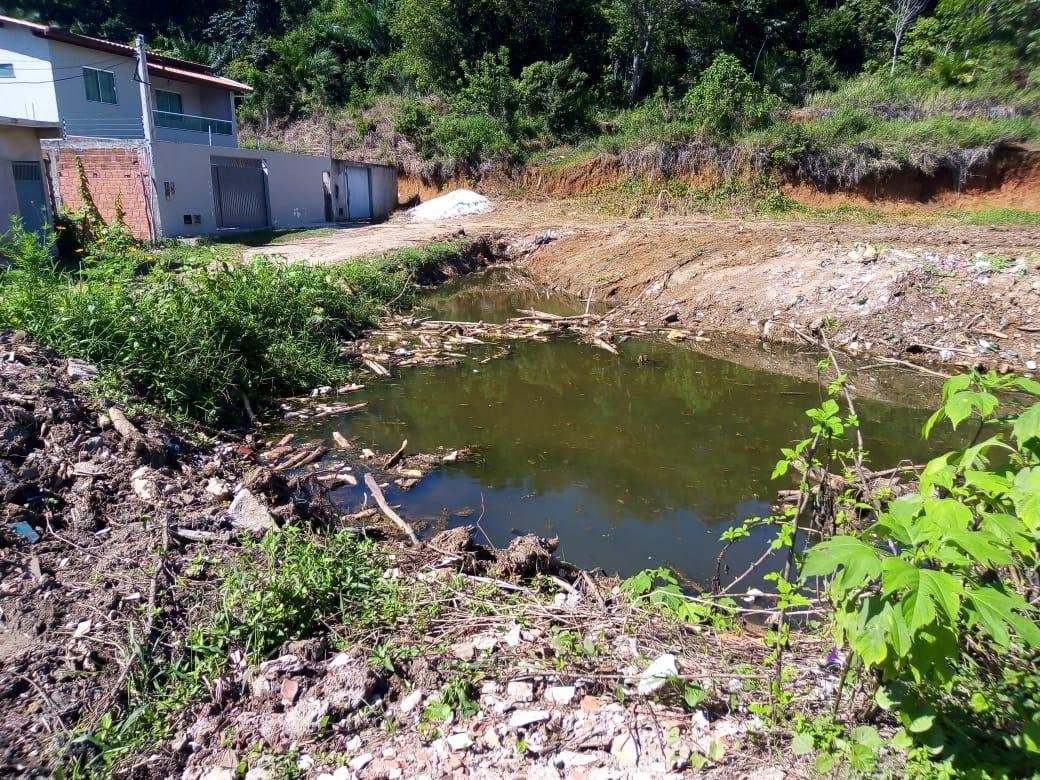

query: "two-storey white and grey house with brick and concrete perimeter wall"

left=0, top=16, right=397, bottom=238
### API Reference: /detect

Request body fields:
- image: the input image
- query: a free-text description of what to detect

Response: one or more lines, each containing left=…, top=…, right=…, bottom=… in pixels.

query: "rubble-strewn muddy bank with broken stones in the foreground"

left=0, top=334, right=837, bottom=780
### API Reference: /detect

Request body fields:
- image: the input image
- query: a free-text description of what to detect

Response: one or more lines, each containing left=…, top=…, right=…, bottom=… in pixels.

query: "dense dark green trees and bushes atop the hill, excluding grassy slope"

left=15, top=0, right=1040, bottom=164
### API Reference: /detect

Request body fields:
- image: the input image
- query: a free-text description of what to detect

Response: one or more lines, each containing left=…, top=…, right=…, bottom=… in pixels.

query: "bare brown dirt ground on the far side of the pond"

left=251, top=201, right=1040, bottom=371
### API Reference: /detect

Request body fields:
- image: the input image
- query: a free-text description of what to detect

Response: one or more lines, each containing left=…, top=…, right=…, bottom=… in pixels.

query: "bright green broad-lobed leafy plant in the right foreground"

left=801, top=373, right=1040, bottom=769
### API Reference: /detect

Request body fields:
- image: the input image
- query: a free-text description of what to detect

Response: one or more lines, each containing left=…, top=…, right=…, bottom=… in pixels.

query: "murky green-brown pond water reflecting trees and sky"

left=296, top=274, right=942, bottom=582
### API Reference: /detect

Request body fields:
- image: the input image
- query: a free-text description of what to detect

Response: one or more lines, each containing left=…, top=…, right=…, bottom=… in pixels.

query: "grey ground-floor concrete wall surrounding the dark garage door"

left=153, top=141, right=332, bottom=236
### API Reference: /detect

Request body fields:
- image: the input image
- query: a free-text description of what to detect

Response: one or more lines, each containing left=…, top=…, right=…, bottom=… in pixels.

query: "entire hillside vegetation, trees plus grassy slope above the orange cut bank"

left=14, top=0, right=1040, bottom=186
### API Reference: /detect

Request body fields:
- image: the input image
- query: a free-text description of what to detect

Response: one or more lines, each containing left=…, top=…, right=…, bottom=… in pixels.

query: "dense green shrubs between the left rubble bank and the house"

left=0, top=222, right=458, bottom=421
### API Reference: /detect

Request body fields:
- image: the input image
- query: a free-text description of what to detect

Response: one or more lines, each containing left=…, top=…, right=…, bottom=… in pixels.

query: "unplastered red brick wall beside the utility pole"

left=52, top=147, right=152, bottom=239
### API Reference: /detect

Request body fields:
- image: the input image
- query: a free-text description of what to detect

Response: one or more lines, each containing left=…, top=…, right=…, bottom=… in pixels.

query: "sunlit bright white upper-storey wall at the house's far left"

left=0, top=25, right=58, bottom=122
